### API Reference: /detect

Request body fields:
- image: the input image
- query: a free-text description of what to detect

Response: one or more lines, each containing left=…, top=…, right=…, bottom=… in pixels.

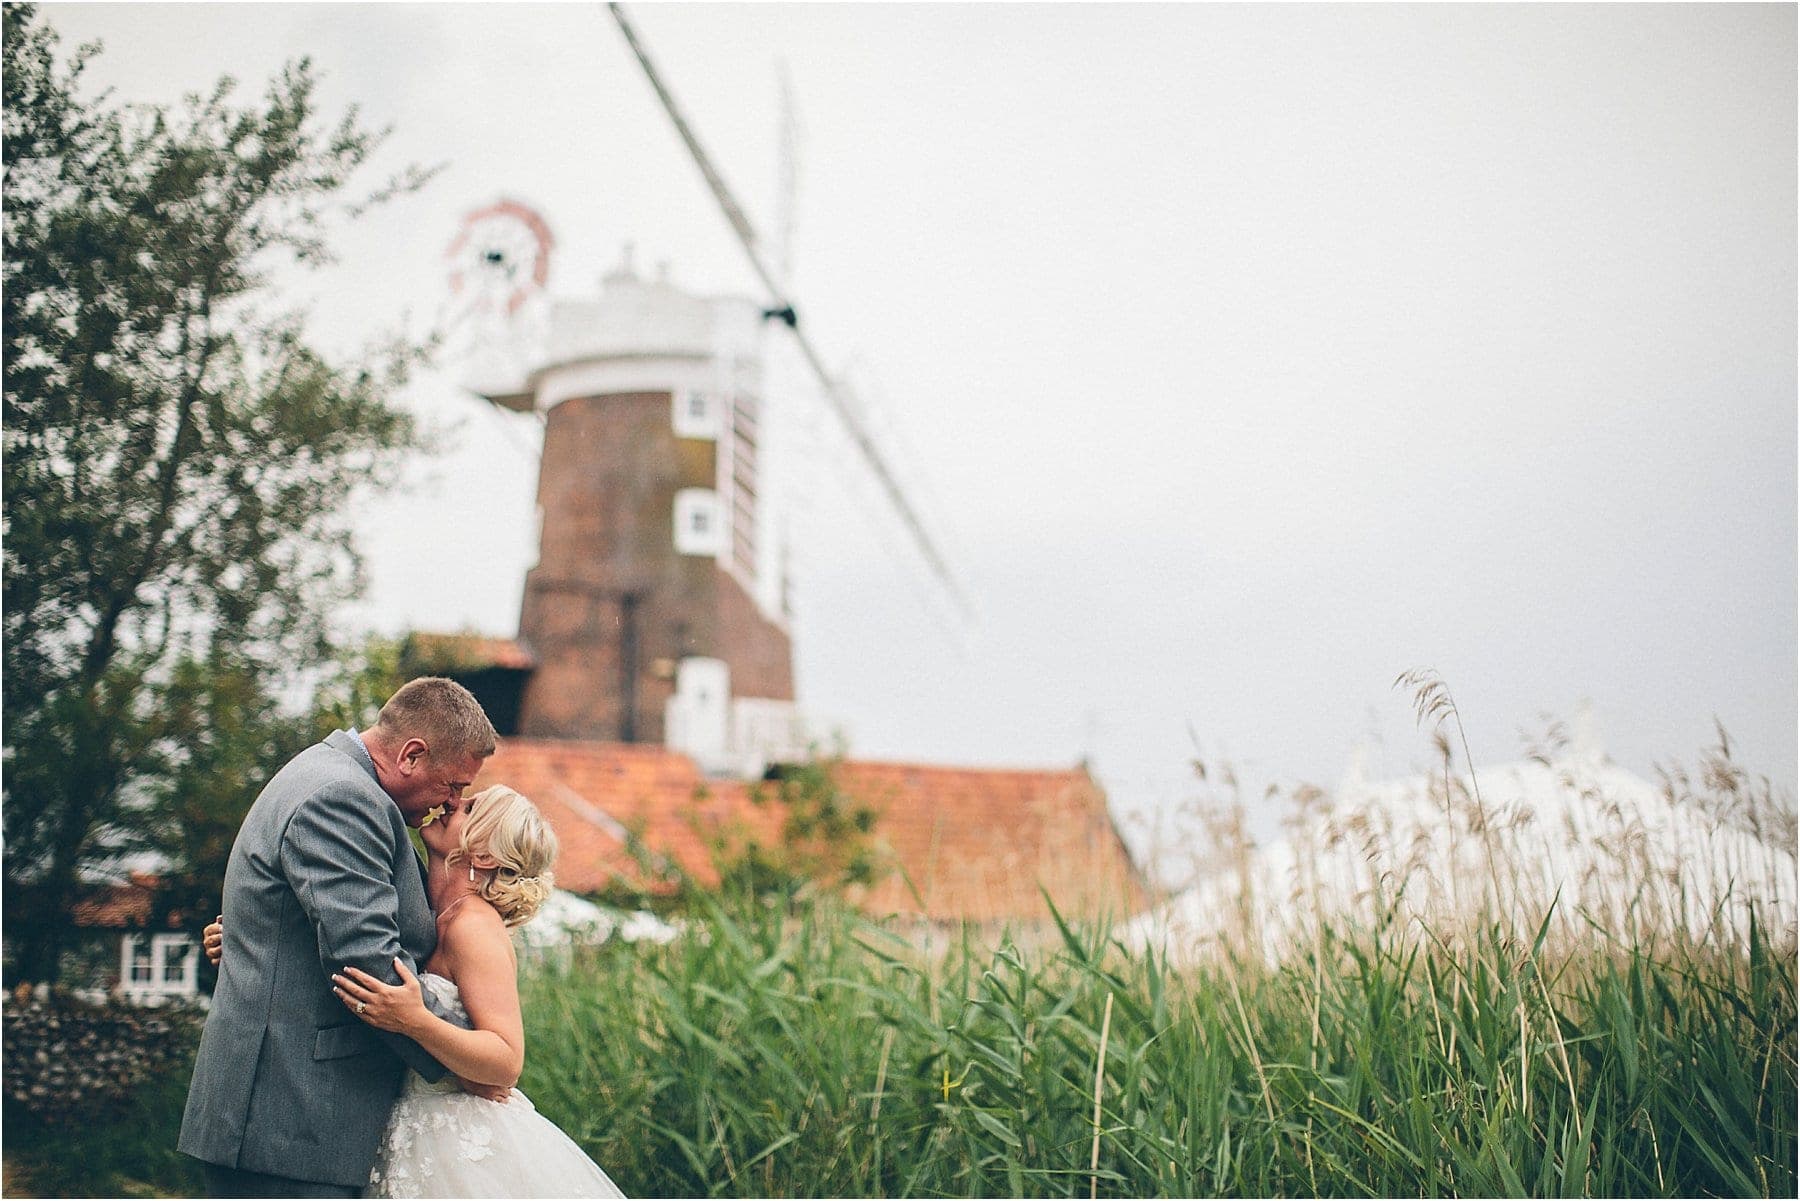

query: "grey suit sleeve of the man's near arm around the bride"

left=281, top=785, right=445, bottom=1080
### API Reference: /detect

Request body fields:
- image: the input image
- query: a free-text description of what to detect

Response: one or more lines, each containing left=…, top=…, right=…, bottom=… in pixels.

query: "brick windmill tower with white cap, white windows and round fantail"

left=439, top=200, right=803, bottom=772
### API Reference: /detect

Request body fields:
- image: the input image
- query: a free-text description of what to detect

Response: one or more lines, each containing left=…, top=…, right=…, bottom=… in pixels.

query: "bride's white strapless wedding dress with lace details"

left=362, top=972, right=625, bottom=1197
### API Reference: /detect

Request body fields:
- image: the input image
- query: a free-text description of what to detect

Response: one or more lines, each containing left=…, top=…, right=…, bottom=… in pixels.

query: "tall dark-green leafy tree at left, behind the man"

left=0, top=4, right=425, bottom=980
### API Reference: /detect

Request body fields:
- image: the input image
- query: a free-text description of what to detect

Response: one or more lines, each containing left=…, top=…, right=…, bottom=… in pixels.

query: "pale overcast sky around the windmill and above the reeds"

left=35, top=4, right=1796, bottom=849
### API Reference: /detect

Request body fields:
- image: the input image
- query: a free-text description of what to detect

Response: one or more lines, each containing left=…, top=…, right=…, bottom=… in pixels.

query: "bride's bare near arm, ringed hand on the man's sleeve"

left=331, top=906, right=526, bottom=1088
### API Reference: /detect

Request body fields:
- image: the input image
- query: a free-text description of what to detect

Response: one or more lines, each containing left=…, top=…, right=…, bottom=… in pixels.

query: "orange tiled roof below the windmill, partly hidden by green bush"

left=475, top=738, right=1145, bottom=920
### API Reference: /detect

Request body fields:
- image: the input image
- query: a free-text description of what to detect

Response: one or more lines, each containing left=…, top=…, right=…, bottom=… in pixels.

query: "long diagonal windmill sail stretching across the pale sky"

left=607, top=4, right=970, bottom=616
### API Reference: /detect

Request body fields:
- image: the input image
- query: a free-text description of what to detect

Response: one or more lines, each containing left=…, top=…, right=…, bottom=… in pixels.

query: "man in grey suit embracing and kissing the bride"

left=178, top=677, right=495, bottom=1197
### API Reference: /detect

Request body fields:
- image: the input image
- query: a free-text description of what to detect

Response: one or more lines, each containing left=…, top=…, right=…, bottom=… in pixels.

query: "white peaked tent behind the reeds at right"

left=1120, top=753, right=1796, bottom=960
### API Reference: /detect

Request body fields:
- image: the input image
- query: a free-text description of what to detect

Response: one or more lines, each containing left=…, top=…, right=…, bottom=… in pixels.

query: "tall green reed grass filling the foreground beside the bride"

left=524, top=900, right=1796, bottom=1197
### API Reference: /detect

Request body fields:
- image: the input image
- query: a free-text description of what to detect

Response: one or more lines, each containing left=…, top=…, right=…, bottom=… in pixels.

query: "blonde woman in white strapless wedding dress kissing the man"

left=207, top=787, right=625, bottom=1197
